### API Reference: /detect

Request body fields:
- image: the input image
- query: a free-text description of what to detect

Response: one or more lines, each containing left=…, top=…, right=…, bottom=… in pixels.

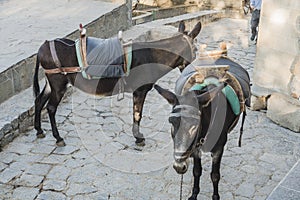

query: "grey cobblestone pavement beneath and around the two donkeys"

left=0, top=19, right=300, bottom=200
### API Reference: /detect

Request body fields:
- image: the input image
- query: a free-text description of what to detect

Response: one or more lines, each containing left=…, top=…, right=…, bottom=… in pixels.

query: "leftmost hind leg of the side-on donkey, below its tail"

left=34, top=80, right=51, bottom=138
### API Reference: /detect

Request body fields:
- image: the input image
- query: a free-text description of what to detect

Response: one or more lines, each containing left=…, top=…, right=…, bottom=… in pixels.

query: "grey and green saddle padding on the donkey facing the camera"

left=175, top=57, right=251, bottom=114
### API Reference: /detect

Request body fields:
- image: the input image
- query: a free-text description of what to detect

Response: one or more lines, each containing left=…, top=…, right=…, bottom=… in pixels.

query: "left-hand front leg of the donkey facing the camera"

left=189, top=150, right=202, bottom=200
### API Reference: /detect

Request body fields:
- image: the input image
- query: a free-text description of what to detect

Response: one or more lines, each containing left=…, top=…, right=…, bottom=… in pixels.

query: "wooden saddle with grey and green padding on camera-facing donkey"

left=175, top=44, right=251, bottom=115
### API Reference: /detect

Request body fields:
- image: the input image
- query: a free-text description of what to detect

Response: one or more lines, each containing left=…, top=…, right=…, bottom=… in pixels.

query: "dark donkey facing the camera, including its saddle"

left=154, top=57, right=250, bottom=200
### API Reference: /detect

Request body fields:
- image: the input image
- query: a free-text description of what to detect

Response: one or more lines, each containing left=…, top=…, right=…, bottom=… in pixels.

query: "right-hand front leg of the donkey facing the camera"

left=210, top=146, right=224, bottom=200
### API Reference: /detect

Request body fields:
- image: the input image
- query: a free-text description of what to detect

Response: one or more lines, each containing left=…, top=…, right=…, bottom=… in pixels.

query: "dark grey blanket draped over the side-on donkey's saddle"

left=76, top=37, right=125, bottom=78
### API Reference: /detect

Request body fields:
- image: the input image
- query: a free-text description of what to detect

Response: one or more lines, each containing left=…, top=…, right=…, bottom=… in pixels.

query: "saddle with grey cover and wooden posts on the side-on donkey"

left=75, top=27, right=132, bottom=79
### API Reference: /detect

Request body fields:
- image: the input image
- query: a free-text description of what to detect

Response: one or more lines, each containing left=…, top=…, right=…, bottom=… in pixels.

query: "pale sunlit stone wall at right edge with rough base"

left=253, top=0, right=300, bottom=132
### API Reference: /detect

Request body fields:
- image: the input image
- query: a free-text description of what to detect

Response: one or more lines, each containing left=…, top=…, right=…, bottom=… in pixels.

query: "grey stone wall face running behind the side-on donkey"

left=0, top=4, right=131, bottom=103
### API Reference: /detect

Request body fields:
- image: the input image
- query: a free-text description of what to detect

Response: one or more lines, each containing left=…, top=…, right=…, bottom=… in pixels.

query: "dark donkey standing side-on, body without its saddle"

left=33, top=22, right=201, bottom=146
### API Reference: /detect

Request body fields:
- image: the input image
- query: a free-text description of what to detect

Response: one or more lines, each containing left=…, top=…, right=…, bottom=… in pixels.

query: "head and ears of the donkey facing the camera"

left=154, top=84, right=225, bottom=174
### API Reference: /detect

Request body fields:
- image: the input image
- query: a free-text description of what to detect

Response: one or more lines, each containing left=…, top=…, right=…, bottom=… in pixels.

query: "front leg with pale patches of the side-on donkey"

left=132, top=84, right=153, bottom=146
